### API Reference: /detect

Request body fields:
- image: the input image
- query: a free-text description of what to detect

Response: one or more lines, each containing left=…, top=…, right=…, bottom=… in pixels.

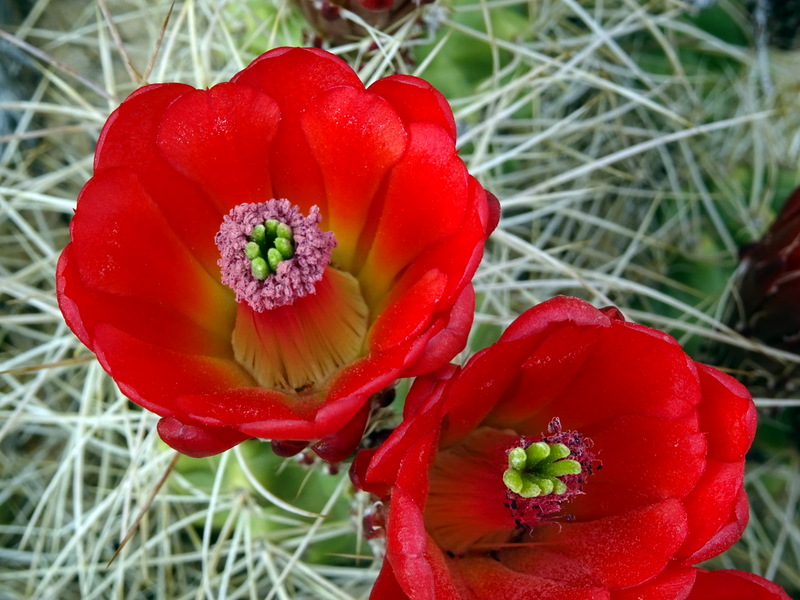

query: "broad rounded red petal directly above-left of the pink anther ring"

left=158, top=83, right=280, bottom=213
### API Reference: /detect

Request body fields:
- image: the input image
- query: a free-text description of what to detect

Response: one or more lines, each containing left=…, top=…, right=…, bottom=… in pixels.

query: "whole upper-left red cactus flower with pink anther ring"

left=57, top=48, right=497, bottom=460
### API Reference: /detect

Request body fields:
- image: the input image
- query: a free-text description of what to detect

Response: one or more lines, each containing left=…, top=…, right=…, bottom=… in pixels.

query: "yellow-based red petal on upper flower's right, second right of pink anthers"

left=359, top=123, right=472, bottom=306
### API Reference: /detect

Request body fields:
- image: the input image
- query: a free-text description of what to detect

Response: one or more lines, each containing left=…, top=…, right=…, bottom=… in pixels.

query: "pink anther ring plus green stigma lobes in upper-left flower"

left=215, top=199, right=336, bottom=312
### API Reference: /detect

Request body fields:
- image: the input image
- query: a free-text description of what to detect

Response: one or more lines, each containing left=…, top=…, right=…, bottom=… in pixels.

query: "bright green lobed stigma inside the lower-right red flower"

left=503, top=442, right=581, bottom=498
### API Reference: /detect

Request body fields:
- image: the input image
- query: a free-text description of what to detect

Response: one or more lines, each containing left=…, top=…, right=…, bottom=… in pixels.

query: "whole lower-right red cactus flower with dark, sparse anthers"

left=351, top=297, right=788, bottom=600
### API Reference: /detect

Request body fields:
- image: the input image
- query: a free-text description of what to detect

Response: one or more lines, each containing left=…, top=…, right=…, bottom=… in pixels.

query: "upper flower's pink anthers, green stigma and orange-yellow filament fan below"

left=216, top=199, right=369, bottom=395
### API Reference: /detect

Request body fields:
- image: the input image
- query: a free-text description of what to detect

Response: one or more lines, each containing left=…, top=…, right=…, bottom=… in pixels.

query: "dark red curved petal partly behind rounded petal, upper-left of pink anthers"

left=95, top=83, right=223, bottom=278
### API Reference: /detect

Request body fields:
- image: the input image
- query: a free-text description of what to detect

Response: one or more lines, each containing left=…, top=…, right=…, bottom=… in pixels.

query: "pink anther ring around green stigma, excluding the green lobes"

left=214, top=199, right=336, bottom=312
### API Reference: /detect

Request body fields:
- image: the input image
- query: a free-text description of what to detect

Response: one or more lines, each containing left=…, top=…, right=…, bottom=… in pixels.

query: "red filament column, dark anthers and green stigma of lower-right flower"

left=425, top=419, right=598, bottom=555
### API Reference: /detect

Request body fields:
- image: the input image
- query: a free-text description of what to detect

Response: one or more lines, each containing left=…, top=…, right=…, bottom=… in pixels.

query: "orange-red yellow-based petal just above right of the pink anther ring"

left=301, top=87, right=406, bottom=270
